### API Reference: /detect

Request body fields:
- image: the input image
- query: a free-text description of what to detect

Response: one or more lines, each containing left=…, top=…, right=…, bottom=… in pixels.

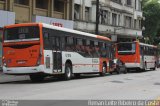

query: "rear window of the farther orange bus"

left=117, top=43, right=136, bottom=55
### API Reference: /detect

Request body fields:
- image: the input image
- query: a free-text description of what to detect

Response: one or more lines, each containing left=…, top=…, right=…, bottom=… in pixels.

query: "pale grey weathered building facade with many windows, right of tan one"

left=74, top=0, right=143, bottom=41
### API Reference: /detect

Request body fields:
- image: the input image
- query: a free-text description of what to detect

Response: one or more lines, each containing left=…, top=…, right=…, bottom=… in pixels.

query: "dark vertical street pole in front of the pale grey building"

left=95, top=0, right=99, bottom=35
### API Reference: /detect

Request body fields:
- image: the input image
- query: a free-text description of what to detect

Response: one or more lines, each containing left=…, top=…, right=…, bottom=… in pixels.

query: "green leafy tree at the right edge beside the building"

left=142, top=0, right=160, bottom=44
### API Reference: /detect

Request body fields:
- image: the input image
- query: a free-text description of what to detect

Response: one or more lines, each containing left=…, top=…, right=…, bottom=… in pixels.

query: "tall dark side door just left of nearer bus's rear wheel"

left=52, top=36, right=62, bottom=73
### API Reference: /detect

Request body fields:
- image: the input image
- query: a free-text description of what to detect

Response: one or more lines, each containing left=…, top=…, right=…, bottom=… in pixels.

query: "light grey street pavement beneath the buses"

left=0, top=69, right=160, bottom=100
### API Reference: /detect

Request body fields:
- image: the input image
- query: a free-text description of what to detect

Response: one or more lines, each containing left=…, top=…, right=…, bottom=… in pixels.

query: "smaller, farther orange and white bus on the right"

left=116, top=41, right=158, bottom=70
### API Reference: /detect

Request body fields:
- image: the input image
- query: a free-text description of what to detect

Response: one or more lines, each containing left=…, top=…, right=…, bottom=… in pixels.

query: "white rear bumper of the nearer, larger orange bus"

left=3, top=65, right=44, bottom=75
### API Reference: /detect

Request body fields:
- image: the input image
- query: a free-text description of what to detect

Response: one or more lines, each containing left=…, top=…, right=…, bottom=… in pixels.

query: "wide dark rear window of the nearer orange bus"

left=4, top=26, right=40, bottom=41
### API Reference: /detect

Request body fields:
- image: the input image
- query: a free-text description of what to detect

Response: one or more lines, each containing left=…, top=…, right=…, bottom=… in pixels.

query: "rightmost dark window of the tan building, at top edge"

left=54, top=0, right=64, bottom=13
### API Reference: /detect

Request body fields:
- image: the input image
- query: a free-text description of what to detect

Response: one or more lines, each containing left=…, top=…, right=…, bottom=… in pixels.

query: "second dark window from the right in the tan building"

left=36, top=0, right=48, bottom=9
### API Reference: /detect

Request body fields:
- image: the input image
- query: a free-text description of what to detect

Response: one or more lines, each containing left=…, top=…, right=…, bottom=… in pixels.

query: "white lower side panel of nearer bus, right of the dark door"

left=62, top=52, right=99, bottom=73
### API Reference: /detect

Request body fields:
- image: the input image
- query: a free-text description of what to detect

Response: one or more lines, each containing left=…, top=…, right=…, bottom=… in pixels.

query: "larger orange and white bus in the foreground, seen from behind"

left=3, top=23, right=113, bottom=81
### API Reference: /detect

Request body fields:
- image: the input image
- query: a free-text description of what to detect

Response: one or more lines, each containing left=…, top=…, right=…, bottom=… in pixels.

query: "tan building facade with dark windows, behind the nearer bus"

left=0, top=0, right=73, bottom=27
